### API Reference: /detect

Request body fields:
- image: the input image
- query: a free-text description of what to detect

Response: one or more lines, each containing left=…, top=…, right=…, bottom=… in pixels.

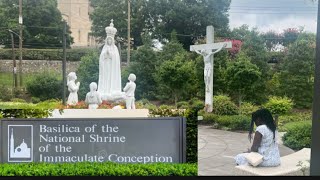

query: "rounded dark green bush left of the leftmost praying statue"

left=27, top=72, right=63, bottom=101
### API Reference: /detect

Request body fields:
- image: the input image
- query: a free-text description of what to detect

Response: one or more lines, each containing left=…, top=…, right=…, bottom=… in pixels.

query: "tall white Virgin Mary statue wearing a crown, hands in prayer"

left=98, top=20, right=124, bottom=101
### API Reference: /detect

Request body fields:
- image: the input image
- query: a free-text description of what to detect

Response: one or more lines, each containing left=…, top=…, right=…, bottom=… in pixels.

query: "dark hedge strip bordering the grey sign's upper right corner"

left=149, top=108, right=198, bottom=163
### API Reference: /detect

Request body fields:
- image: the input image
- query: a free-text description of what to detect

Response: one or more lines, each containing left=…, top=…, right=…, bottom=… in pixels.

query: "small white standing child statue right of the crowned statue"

left=123, top=73, right=136, bottom=109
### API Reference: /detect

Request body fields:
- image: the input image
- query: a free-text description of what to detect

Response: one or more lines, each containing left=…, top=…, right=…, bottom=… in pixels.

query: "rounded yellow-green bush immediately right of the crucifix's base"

left=213, top=95, right=238, bottom=115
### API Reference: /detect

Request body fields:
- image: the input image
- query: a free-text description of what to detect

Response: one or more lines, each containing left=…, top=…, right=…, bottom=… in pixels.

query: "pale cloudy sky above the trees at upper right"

left=229, top=0, right=317, bottom=33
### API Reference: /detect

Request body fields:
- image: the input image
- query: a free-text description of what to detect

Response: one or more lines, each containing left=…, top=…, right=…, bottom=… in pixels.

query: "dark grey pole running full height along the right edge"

left=310, top=1, right=320, bottom=176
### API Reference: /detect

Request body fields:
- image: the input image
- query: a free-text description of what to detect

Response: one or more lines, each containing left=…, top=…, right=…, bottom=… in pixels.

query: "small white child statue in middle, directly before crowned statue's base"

left=85, top=82, right=102, bottom=109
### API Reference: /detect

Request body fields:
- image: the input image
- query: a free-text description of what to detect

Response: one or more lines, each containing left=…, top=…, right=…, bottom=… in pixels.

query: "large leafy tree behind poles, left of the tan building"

left=0, top=0, right=73, bottom=48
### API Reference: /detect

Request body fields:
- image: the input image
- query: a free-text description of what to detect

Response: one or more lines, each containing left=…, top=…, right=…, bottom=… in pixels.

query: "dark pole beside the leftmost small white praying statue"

left=62, top=21, right=67, bottom=105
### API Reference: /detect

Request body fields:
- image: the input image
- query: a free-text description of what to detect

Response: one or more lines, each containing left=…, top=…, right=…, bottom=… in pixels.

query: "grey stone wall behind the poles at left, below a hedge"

left=0, top=60, right=80, bottom=73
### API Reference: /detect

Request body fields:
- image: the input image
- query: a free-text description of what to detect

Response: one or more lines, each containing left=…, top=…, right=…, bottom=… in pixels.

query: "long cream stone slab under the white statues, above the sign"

left=49, top=109, right=149, bottom=118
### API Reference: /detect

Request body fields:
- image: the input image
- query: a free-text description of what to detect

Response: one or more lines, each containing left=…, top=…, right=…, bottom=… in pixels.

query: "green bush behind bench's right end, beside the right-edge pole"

left=282, top=121, right=312, bottom=150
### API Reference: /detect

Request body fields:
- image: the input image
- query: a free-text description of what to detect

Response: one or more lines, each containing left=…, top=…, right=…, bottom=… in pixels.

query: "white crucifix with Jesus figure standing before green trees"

left=190, top=26, right=232, bottom=112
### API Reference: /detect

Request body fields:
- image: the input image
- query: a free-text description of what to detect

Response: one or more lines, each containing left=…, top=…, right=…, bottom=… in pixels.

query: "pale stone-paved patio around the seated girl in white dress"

left=198, top=125, right=294, bottom=176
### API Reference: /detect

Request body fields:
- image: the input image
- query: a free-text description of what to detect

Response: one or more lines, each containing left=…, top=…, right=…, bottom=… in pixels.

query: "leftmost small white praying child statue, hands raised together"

left=67, top=72, right=80, bottom=105
